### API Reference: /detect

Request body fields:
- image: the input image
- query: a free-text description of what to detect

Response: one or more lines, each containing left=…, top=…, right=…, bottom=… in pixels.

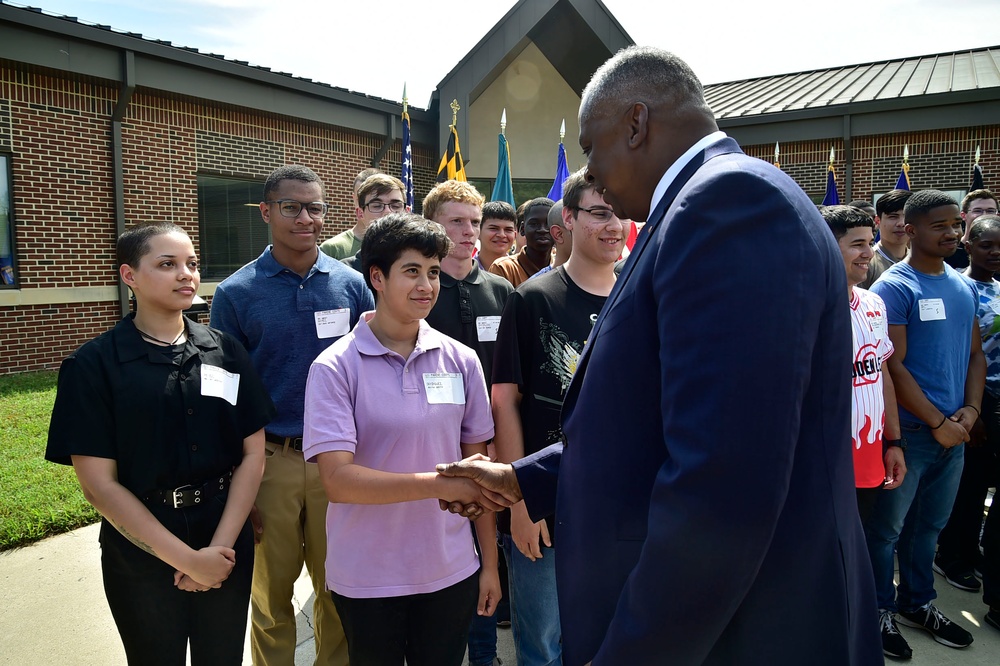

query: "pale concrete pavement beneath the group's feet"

left=0, top=525, right=1000, bottom=666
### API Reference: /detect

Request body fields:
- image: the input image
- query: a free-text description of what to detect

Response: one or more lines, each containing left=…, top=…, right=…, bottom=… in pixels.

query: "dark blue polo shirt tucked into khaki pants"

left=210, top=245, right=375, bottom=437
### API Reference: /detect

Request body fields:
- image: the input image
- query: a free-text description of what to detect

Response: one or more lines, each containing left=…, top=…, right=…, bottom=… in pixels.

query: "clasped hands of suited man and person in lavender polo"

left=437, top=453, right=521, bottom=520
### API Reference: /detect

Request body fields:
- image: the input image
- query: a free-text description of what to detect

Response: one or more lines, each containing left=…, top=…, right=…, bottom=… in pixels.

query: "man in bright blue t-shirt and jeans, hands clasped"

left=866, top=190, right=986, bottom=659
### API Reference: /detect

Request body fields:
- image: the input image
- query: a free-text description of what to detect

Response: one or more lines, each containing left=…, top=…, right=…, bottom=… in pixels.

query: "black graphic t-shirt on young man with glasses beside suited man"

left=493, top=266, right=607, bottom=534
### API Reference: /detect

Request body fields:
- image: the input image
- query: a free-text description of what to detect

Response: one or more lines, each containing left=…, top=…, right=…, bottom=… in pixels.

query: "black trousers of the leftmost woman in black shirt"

left=101, top=497, right=253, bottom=666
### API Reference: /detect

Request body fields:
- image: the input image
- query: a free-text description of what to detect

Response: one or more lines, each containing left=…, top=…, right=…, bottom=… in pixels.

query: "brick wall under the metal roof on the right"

left=743, top=125, right=1000, bottom=203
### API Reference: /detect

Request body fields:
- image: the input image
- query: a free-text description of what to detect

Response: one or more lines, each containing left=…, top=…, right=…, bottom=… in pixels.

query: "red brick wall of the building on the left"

left=0, top=60, right=437, bottom=374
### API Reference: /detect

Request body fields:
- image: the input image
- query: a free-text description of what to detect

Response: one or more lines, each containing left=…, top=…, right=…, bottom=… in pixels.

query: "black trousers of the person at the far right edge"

left=936, top=393, right=1000, bottom=570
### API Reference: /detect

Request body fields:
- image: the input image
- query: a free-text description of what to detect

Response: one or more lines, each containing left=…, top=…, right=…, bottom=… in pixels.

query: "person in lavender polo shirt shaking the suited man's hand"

left=303, top=213, right=500, bottom=666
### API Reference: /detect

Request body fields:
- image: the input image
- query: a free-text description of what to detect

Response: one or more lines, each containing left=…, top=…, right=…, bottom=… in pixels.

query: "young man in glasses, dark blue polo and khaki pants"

left=211, top=165, right=375, bottom=665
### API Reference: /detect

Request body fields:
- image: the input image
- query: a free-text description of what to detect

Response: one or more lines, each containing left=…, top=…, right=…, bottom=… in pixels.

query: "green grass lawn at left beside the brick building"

left=0, top=372, right=100, bottom=550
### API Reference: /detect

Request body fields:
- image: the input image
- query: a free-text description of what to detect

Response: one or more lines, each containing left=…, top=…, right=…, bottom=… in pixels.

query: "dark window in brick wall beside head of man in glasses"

left=198, top=176, right=271, bottom=280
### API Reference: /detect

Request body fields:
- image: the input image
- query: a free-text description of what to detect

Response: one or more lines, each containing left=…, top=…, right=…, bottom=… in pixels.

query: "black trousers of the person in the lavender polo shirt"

left=330, top=573, right=479, bottom=666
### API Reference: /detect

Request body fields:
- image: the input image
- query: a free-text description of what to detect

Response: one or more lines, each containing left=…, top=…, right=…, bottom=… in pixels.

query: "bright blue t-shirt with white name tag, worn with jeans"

left=871, top=262, right=979, bottom=425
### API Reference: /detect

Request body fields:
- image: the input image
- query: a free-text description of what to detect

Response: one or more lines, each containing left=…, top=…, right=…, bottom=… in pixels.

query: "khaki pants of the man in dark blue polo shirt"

left=250, top=442, right=348, bottom=666
